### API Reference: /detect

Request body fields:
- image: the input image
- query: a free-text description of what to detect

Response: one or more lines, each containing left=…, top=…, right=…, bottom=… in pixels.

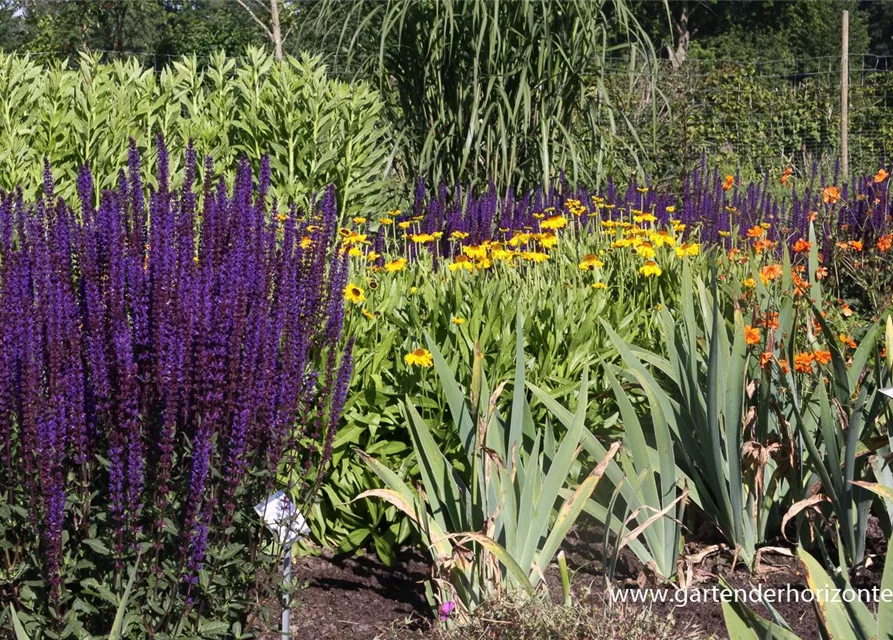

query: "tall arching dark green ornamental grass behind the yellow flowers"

left=302, top=0, right=653, bottom=190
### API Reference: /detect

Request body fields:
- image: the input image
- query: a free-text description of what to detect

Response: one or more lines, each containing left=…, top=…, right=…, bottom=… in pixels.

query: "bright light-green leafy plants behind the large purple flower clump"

left=0, top=49, right=387, bottom=215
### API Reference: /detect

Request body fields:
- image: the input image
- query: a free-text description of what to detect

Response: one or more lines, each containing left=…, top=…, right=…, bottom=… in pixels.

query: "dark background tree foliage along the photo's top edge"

left=0, top=0, right=893, bottom=59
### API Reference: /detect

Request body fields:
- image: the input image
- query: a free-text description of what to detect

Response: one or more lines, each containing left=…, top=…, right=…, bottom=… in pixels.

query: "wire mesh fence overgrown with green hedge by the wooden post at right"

left=610, top=54, right=893, bottom=180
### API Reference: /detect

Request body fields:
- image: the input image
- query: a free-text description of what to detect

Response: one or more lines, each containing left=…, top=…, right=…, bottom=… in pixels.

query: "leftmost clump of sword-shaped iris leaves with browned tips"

left=358, top=319, right=619, bottom=617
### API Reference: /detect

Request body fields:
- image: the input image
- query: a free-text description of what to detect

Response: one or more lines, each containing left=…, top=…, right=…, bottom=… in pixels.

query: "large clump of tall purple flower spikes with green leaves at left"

left=0, top=141, right=352, bottom=637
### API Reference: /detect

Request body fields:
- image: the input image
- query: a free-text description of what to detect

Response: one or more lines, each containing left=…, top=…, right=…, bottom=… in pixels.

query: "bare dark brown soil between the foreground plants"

left=286, top=520, right=886, bottom=640
